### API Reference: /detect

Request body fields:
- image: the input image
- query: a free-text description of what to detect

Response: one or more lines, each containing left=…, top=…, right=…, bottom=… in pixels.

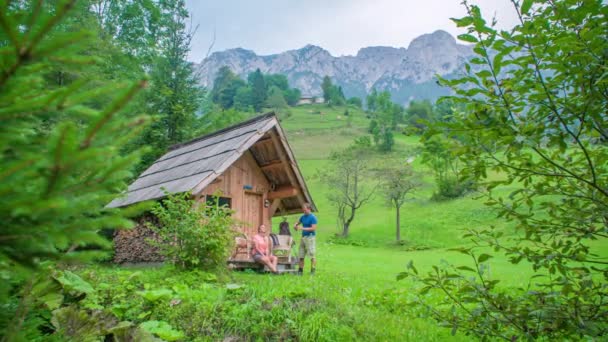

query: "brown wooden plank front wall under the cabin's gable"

left=201, top=151, right=271, bottom=237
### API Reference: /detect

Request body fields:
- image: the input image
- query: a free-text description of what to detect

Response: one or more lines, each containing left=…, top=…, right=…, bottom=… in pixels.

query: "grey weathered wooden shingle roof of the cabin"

left=108, top=113, right=314, bottom=211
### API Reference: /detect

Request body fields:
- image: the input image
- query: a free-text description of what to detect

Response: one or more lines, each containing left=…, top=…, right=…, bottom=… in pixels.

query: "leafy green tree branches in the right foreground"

left=400, top=0, right=608, bottom=340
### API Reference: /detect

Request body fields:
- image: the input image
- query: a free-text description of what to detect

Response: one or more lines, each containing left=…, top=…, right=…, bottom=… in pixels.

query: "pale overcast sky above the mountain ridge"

left=186, top=0, right=516, bottom=62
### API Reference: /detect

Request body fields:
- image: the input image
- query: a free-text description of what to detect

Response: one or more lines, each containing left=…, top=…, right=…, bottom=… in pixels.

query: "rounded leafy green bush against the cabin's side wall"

left=149, top=193, right=235, bottom=270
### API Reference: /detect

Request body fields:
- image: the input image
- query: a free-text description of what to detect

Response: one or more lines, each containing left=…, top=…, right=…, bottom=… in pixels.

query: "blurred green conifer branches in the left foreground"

left=0, top=0, right=147, bottom=340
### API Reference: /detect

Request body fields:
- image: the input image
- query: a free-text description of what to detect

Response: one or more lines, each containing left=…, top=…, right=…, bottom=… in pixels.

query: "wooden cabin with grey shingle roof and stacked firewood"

left=108, top=113, right=317, bottom=263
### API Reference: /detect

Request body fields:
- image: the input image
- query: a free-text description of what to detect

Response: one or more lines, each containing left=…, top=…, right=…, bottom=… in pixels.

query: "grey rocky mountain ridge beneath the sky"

left=197, top=31, right=473, bottom=103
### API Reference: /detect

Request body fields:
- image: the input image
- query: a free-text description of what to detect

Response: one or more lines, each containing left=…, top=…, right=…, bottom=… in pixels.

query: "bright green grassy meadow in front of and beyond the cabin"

left=82, top=105, right=602, bottom=341
